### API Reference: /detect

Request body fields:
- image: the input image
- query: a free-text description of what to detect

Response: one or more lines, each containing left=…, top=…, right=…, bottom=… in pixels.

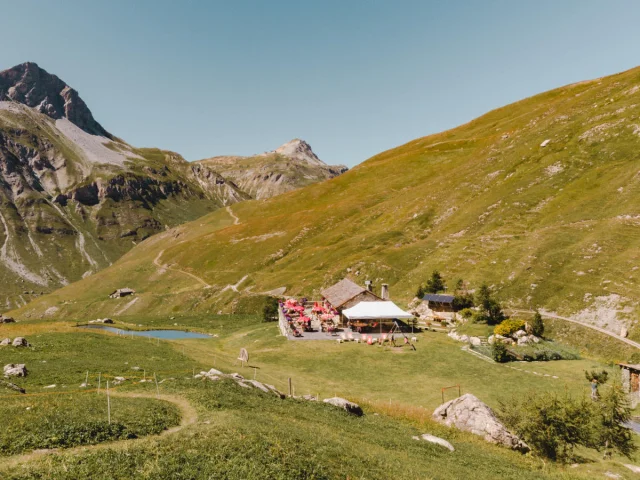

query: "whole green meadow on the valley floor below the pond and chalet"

left=0, top=315, right=629, bottom=479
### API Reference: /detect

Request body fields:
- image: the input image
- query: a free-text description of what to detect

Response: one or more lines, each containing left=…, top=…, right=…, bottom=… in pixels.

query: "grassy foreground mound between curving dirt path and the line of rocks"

left=0, top=380, right=623, bottom=480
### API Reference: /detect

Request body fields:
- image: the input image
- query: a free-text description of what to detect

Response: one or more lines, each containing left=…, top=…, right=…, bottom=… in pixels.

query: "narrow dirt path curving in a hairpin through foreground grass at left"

left=0, top=391, right=198, bottom=472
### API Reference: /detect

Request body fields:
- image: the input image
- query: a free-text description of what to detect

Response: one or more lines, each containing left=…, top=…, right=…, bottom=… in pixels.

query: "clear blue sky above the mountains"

left=0, top=0, right=640, bottom=165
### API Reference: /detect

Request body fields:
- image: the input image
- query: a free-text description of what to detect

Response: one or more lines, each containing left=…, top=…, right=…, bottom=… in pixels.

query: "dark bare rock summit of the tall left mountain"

left=0, top=62, right=112, bottom=138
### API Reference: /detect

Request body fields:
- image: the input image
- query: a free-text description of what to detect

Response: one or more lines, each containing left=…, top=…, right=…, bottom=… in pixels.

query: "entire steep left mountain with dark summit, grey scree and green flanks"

left=0, top=63, right=249, bottom=310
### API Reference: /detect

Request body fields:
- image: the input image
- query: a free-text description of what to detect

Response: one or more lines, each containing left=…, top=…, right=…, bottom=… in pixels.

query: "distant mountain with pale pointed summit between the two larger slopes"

left=198, top=139, right=348, bottom=199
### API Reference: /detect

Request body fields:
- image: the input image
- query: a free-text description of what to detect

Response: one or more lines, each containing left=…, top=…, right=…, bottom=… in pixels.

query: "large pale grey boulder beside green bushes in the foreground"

left=433, top=393, right=529, bottom=452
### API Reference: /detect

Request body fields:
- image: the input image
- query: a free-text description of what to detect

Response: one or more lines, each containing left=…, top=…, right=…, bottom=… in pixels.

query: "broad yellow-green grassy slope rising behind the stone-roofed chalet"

left=8, top=65, right=640, bottom=336
